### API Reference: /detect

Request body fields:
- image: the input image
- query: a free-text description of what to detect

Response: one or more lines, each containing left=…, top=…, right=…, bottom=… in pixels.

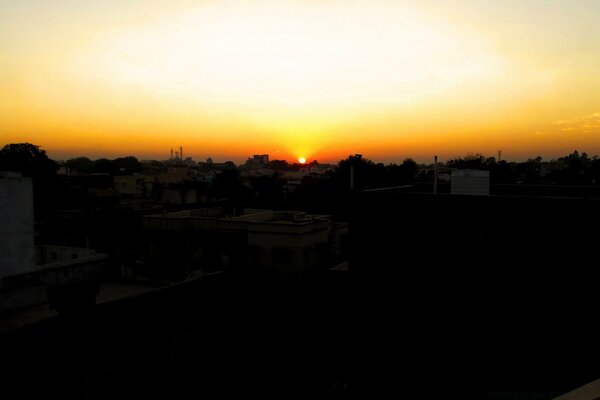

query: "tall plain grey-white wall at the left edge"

left=0, top=172, right=35, bottom=279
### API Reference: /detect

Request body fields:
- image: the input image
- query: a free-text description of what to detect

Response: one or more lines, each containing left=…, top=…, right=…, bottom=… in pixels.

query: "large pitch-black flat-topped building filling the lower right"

left=349, top=191, right=600, bottom=398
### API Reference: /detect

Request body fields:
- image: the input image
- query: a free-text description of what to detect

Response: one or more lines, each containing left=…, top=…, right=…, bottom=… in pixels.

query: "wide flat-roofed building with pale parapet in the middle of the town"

left=138, top=208, right=347, bottom=279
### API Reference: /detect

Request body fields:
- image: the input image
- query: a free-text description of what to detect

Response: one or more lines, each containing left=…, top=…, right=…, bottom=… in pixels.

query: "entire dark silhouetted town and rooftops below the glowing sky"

left=0, top=143, right=600, bottom=399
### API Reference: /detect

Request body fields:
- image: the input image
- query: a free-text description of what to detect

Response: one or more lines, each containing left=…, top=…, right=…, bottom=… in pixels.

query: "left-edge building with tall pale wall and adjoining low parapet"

left=0, top=173, right=107, bottom=312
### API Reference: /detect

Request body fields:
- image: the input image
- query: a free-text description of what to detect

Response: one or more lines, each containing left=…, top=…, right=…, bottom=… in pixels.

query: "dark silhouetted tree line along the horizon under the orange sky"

left=0, top=143, right=600, bottom=222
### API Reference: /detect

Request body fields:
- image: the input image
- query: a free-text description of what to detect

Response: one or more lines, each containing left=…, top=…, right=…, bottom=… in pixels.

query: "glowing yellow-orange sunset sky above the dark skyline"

left=0, top=0, right=600, bottom=163
